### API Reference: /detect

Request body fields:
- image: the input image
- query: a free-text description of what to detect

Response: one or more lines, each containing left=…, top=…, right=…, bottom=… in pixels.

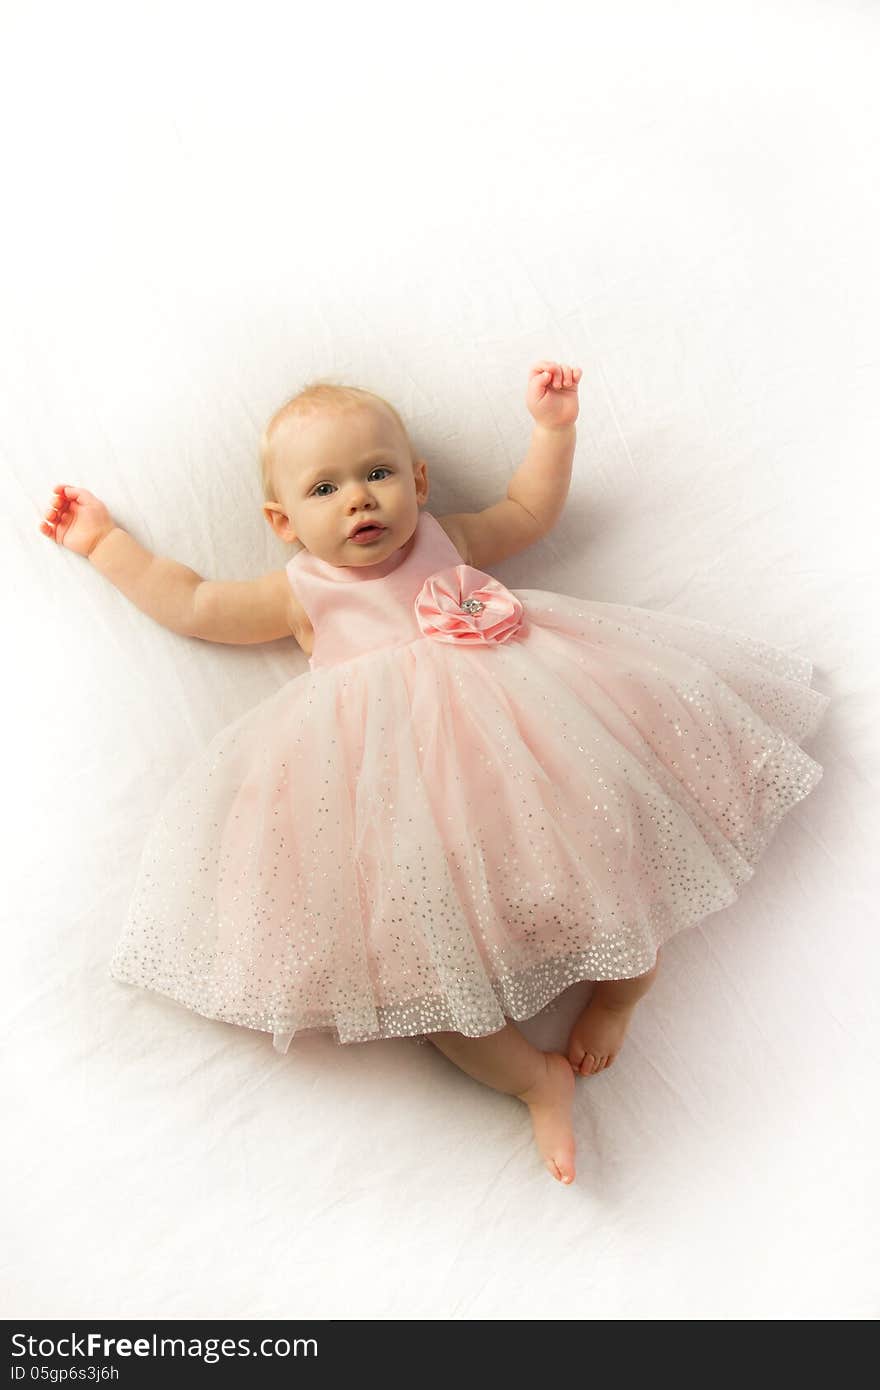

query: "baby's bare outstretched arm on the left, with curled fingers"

left=40, top=487, right=299, bottom=644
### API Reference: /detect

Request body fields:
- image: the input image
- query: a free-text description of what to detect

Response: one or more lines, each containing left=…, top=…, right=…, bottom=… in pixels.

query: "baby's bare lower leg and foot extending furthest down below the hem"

left=427, top=1022, right=574, bottom=1183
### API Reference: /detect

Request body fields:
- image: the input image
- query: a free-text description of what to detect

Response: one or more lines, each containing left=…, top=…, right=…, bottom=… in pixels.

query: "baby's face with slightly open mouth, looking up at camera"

left=264, top=404, right=428, bottom=566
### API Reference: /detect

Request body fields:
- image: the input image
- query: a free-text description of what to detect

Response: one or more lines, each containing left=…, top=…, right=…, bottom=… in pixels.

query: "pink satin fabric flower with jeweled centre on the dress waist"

left=416, top=564, right=523, bottom=646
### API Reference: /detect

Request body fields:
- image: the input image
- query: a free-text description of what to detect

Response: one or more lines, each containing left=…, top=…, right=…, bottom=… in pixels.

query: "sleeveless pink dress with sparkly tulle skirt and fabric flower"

left=110, top=510, right=830, bottom=1052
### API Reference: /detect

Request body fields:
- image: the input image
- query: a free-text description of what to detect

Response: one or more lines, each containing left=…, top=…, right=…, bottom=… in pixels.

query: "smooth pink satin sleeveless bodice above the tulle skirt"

left=285, top=509, right=464, bottom=670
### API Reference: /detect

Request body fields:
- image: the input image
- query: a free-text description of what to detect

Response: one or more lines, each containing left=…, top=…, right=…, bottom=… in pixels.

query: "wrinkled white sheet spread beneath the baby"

left=0, top=0, right=880, bottom=1319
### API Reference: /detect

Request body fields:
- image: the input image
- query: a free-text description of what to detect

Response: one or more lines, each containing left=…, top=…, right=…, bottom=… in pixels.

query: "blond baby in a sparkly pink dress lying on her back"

left=40, top=361, right=824, bottom=1184
